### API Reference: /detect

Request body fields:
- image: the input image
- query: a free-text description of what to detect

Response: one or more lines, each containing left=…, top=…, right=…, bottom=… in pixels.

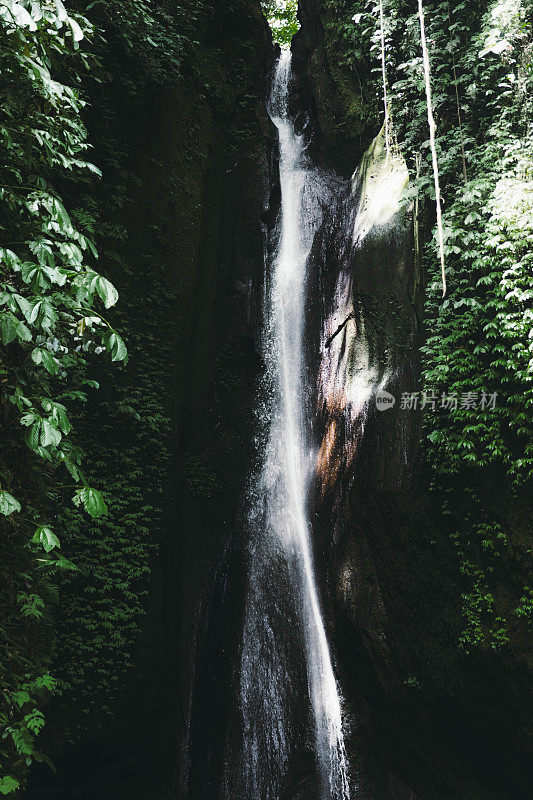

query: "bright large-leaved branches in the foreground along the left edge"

left=0, top=0, right=126, bottom=794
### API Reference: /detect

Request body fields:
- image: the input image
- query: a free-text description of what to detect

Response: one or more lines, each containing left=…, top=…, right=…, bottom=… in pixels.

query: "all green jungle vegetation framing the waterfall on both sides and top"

left=0, top=0, right=533, bottom=796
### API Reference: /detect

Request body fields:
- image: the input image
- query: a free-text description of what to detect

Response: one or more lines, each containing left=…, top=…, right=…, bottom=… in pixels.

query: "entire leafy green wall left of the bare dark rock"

left=0, top=0, right=270, bottom=796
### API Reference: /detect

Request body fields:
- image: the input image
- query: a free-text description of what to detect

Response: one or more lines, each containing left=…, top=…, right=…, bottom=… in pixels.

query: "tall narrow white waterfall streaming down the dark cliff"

left=241, top=50, right=350, bottom=800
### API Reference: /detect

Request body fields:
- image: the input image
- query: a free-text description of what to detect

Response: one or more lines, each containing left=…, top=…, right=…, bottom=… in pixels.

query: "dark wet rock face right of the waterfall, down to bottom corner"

left=295, top=6, right=530, bottom=800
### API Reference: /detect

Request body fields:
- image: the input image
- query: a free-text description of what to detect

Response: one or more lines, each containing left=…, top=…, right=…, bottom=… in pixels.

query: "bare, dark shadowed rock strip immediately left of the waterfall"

left=162, top=9, right=279, bottom=800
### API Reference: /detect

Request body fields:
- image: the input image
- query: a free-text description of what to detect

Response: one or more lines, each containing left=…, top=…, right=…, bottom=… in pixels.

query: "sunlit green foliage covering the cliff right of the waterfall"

left=328, top=0, right=533, bottom=650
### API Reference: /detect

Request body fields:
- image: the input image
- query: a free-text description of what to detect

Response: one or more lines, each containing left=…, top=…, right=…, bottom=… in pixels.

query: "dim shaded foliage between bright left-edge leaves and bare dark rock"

left=29, top=0, right=264, bottom=756
